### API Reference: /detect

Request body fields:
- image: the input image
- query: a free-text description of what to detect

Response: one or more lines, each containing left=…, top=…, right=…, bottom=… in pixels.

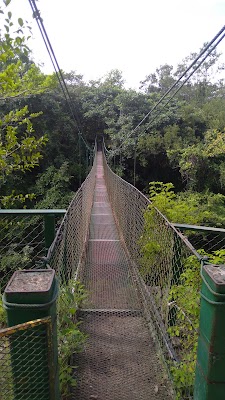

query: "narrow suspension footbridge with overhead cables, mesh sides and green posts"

left=0, top=0, right=225, bottom=400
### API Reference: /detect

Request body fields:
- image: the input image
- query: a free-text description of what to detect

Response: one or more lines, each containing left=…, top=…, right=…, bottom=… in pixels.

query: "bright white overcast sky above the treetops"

left=6, top=0, right=225, bottom=89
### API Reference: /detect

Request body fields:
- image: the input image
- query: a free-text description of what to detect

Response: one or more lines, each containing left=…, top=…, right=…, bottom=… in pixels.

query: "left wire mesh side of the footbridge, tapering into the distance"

left=47, top=152, right=96, bottom=284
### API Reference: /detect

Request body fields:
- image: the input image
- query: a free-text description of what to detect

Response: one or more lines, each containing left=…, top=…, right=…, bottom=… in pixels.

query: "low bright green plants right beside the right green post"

left=168, top=249, right=225, bottom=400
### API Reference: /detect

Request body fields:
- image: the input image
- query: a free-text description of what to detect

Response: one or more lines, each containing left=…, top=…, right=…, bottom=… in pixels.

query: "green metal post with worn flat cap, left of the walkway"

left=3, top=269, right=60, bottom=400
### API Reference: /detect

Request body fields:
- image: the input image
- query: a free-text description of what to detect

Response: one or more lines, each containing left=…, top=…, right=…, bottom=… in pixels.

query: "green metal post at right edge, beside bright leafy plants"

left=194, top=265, right=225, bottom=400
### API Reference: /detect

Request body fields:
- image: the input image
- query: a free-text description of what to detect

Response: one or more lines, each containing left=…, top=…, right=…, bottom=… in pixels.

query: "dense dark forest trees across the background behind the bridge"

left=0, top=1, right=225, bottom=214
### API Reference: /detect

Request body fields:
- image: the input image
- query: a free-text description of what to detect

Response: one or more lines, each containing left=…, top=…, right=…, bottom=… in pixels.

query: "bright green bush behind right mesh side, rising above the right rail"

left=140, top=182, right=225, bottom=282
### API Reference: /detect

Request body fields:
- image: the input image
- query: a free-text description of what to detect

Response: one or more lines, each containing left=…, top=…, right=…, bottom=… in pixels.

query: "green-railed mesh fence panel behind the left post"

left=0, top=210, right=66, bottom=291
